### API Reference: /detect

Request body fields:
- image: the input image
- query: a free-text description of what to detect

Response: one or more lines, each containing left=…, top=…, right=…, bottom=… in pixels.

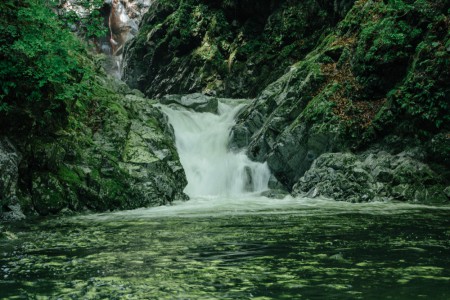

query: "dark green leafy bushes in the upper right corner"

left=339, top=0, right=450, bottom=138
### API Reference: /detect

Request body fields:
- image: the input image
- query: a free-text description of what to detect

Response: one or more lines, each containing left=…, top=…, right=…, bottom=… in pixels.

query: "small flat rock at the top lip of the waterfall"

left=159, top=93, right=218, bottom=113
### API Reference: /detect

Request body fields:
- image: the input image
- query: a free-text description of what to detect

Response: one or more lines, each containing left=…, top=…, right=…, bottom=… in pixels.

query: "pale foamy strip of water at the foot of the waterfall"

left=77, top=195, right=450, bottom=221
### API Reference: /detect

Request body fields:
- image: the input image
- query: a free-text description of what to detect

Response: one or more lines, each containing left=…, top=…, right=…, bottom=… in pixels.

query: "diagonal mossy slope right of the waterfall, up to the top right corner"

left=235, top=1, right=450, bottom=201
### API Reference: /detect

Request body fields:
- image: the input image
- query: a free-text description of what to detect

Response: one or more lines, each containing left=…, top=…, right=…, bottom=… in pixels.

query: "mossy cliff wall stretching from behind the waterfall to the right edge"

left=124, top=0, right=450, bottom=201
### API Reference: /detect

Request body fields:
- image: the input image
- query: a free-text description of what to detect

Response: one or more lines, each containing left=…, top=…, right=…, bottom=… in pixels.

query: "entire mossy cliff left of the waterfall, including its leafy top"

left=0, top=0, right=186, bottom=218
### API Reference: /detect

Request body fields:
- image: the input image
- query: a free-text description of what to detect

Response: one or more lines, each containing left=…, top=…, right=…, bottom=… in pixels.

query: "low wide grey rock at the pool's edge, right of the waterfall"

left=293, top=152, right=448, bottom=203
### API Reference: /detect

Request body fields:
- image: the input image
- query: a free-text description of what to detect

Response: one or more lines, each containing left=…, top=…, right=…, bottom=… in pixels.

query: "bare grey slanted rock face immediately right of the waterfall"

left=231, top=58, right=341, bottom=190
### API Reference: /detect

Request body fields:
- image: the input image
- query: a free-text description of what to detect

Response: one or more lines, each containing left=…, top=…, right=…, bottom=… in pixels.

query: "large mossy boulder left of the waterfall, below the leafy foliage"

left=12, top=79, right=187, bottom=215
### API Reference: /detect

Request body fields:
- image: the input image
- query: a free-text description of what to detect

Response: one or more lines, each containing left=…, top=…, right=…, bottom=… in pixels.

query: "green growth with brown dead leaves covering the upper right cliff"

left=292, top=1, right=450, bottom=147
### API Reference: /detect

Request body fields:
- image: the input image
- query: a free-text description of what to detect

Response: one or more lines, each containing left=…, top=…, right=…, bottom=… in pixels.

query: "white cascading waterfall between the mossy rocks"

left=161, top=102, right=270, bottom=197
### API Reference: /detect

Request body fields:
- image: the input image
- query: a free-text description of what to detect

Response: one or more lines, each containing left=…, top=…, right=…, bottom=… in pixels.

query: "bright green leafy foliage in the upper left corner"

left=0, top=0, right=93, bottom=132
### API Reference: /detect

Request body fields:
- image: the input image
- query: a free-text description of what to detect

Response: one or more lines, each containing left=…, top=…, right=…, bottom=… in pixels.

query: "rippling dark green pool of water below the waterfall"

left=0, top=199, right=450, bottom=299
